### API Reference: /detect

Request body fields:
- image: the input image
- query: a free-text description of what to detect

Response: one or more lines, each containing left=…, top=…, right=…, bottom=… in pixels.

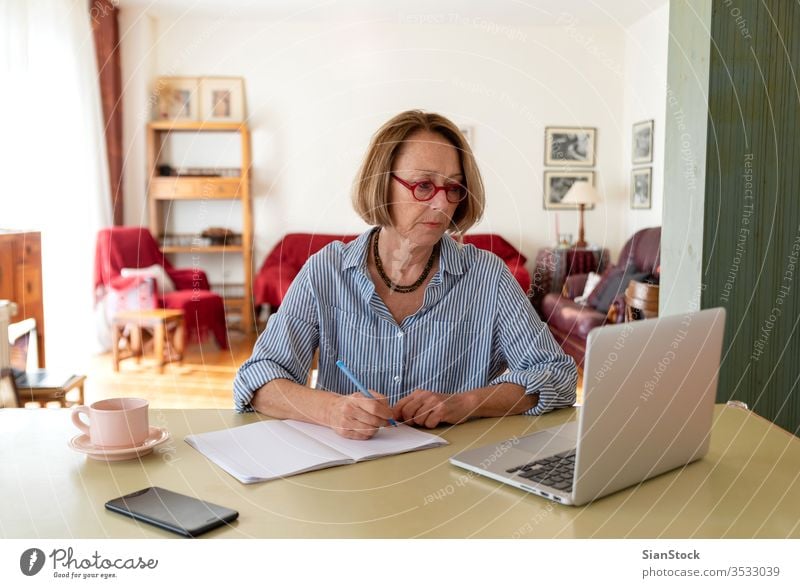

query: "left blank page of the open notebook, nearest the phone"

left=185, top=421, right=352, bottom=484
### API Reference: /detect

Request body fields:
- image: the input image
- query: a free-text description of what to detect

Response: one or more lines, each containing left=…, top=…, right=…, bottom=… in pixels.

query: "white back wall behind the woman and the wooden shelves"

left=121, top=8, right=667, bottom=279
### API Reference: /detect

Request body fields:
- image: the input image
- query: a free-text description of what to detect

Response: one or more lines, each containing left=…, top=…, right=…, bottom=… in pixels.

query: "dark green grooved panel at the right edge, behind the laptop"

left=702, top=0, right=800, bottom=434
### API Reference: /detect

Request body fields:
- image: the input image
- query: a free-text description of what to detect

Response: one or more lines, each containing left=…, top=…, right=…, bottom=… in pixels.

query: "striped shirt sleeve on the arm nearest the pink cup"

left=233, top=263, right=319, bottom=412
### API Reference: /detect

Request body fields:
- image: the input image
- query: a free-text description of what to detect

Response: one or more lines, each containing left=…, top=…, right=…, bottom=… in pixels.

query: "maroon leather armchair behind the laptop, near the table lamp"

left=541, top=227, right=661, bottom=367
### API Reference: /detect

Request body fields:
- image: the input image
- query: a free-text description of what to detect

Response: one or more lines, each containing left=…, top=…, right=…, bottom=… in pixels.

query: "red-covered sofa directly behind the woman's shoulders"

left=253, top=233, right=531, bottom=310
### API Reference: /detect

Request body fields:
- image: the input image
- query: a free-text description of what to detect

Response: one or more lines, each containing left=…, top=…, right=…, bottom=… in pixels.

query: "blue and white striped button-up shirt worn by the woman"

left=233, top=232, right=577, bottom=415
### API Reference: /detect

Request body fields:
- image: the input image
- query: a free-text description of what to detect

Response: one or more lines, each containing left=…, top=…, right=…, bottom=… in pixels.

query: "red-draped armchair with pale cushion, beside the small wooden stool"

left=94, top=227, right=228, bottom=349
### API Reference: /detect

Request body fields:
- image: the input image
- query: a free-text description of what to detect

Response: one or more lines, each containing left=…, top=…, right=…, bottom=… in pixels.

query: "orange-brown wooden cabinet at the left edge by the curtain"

left=0, top=230, right=44, bottom=367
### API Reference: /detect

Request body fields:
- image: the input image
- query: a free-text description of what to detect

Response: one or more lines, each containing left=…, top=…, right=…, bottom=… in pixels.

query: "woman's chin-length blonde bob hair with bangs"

left=353, top=110, right=486, bottom=233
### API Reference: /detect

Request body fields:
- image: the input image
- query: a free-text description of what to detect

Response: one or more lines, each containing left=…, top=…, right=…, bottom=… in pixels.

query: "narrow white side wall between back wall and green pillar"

left=623, top=4, right=669, bottom=235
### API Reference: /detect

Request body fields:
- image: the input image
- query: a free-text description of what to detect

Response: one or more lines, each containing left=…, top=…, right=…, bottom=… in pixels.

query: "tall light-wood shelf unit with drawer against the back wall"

left=147, top=121, right=254, bottom=332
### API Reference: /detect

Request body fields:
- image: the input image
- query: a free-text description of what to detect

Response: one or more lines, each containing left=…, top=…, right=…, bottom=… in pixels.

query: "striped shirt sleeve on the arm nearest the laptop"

left=490, top=271, right=578, bottom=415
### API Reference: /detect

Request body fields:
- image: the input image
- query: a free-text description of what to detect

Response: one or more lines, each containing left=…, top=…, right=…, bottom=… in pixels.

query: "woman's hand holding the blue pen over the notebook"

left=328, top=390, right=392, bottom=439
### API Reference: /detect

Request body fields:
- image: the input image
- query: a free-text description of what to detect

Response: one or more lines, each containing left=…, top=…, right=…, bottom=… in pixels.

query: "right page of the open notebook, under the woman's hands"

left=283, top=420, right=448, bottom=461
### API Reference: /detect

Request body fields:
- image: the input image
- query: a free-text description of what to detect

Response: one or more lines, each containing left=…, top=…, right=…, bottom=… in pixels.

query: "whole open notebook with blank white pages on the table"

left=185, top=420, right=447, bottom=484
